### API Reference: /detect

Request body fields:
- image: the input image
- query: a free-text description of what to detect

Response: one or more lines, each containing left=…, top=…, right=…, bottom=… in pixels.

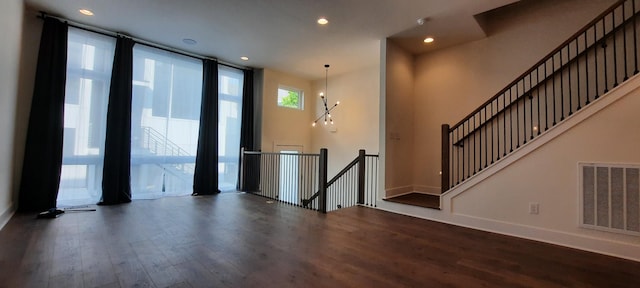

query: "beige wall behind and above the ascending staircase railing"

left=410, top=0, right=614, bottom=191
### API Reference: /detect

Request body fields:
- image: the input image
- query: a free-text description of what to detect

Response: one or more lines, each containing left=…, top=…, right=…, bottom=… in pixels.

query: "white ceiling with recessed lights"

left=25, top=0, right=518, bottom=80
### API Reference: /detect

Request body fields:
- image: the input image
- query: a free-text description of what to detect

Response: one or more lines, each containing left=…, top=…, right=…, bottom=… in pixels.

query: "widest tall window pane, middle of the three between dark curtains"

left=131, top=45, right=202, bottom=199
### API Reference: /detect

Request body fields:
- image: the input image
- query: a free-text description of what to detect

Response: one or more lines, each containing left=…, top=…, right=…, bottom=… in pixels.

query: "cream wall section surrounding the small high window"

left=261, top=69, right=317, bottom=153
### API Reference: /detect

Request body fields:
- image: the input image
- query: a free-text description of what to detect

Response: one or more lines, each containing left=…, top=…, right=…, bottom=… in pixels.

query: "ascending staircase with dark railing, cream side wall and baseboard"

left=378, top=0, right=640, bottom=261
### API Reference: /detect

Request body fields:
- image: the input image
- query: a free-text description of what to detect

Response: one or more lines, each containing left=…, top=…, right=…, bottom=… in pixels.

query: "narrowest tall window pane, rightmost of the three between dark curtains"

left=218, top=65, right=244, bottom=191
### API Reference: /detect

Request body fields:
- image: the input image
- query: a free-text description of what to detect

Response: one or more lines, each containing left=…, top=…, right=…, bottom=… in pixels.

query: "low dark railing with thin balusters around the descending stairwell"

left=240, top=149, right=378, bottom=213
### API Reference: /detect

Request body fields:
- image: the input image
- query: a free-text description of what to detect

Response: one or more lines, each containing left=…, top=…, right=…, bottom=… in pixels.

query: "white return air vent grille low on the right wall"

left=578, top=163, right=640, bottom=235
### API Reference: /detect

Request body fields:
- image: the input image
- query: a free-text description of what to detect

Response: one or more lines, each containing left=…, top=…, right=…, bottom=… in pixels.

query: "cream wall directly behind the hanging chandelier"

left=307, top=62, right=380, bottom=178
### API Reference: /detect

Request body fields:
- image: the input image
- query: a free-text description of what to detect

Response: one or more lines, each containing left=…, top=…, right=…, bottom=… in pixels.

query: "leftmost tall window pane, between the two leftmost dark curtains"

left=58, top=27, right=115, bottom=206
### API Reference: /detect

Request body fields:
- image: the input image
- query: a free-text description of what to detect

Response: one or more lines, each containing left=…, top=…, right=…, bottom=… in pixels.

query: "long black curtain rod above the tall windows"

left=38, top=11, right=251, bottom=70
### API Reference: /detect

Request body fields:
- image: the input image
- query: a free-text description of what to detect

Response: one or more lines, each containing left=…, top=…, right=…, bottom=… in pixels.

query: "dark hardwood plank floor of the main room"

left=0, top=193, right=640, bottom=287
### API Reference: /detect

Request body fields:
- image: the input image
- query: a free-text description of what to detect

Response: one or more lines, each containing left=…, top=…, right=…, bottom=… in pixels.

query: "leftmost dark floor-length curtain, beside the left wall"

left=18, top=18, right=68, bottom=212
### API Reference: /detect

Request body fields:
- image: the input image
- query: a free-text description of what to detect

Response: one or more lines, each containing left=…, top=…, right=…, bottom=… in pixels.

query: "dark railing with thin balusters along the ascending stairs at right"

left=441, top=0, right=640, bottom=192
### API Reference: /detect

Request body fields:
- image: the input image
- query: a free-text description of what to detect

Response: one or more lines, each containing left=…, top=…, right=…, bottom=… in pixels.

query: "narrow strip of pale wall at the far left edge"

left=0, top=0, right=24, bottom=227
